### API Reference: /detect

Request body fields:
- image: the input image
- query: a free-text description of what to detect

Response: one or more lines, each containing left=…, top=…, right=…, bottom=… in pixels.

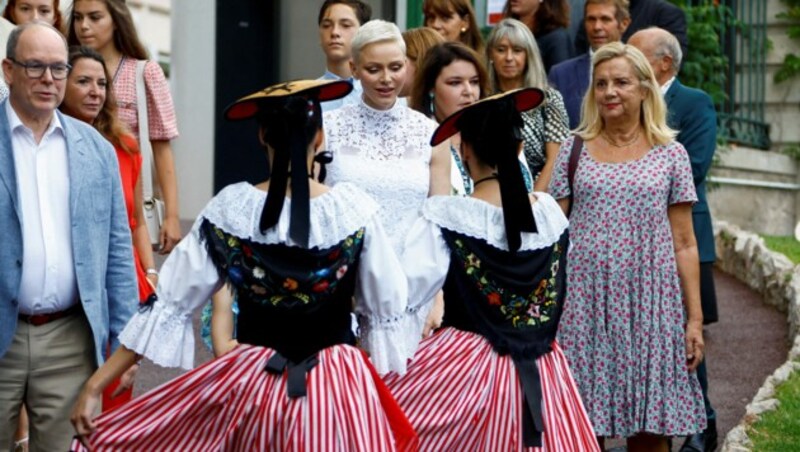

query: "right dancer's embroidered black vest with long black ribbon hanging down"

left=442, top=229, right=568, bottom=447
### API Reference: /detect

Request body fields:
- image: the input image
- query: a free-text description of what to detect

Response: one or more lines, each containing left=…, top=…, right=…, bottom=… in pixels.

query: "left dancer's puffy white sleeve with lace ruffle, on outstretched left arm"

left=119, top=224, right=221, bottom=369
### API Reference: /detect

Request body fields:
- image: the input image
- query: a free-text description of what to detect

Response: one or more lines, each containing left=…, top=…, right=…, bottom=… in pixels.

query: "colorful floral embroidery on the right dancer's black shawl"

left=454, top=239, right=563, bottom=328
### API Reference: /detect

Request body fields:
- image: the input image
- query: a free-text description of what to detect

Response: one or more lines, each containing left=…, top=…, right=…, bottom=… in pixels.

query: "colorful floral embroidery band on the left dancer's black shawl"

left=202, top=221, right=364, bottom=306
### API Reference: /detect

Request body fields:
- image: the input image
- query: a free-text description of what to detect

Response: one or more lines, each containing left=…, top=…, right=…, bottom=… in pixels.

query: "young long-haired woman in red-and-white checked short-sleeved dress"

left=67, top=0, right=181, bottom=254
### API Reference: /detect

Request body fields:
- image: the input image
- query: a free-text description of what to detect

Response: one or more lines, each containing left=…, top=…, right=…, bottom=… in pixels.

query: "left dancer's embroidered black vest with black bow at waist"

left=200, top=220, right=364, bottom=397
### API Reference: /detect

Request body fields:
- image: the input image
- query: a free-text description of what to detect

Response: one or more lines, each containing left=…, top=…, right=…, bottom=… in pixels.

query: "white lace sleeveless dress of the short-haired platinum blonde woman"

left=323, top=100, right=436, bottom=255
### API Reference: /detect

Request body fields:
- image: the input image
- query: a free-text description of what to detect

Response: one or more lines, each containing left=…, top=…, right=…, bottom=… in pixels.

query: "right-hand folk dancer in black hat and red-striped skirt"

left=386, top=88, right=599, bottom=451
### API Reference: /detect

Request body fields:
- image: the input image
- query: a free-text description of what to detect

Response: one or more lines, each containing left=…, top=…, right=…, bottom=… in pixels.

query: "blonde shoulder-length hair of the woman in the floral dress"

left=575, top=42, right=677, bottom=145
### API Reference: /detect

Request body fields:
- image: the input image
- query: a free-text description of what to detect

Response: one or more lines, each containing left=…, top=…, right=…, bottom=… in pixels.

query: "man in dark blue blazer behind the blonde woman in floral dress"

left=547, top=0, right=631, bottom=129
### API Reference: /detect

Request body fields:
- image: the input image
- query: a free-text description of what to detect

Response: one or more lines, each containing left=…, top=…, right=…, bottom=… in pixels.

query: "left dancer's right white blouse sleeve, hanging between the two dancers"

left=355, top=217, right=411, bottom=374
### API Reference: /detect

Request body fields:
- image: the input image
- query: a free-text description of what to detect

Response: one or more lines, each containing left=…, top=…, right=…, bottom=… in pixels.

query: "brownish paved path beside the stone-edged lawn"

left=136, top=271, right=789, bottom=450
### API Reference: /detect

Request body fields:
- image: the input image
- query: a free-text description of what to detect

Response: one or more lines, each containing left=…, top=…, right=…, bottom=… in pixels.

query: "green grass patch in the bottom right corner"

left=747, top=372, right=800, bottom=452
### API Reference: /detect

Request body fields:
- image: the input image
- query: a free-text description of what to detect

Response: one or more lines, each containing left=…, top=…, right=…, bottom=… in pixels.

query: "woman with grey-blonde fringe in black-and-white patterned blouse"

left=486, top=19, right=569, bottom=191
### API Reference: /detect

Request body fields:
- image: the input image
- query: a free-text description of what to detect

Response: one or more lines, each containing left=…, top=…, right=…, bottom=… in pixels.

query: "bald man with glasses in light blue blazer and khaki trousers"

left=0, top=23, right=138, bottom=451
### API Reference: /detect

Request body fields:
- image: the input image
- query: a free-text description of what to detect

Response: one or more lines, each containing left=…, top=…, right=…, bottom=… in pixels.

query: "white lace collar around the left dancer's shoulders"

left=194, top=182, right=378, bottom=248
